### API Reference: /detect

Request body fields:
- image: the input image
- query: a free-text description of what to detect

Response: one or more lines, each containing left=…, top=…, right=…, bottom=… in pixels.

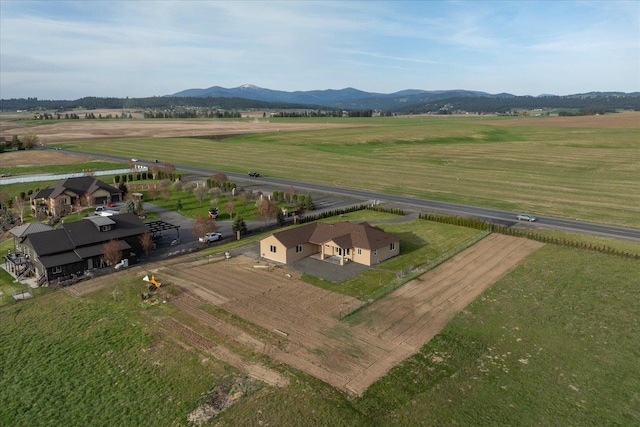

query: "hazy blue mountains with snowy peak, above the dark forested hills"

left=168, top=84, right=640, bottom=111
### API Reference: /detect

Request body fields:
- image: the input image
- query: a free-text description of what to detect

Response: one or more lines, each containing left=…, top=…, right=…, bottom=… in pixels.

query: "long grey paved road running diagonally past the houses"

left=53, top=150, right=640, bottom=241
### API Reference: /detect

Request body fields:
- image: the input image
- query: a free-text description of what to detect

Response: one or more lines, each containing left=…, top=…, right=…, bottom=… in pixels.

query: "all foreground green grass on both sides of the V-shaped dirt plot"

left=0, top=245, right=640, bottom=426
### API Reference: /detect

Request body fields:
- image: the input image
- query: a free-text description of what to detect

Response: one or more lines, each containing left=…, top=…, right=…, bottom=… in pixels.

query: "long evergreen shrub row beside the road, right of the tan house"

left=419, top=214, right=640, bottom=259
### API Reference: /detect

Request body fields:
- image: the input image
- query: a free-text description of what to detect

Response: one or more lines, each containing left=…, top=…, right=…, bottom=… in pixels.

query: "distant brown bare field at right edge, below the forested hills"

left=483, top=111, right=640, bottom=129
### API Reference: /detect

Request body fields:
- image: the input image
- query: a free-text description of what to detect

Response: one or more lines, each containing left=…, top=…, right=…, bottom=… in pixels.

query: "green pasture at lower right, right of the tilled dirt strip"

left=355, top=245, right=640, bottom=425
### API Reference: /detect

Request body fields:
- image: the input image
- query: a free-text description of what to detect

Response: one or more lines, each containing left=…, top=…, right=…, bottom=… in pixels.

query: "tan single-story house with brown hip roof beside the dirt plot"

left=260, top=221, right=400, bottom=265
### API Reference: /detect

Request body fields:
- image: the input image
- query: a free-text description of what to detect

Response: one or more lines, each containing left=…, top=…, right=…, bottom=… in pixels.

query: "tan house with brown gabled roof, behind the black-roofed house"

left=31, top=176, right=123, bottom=216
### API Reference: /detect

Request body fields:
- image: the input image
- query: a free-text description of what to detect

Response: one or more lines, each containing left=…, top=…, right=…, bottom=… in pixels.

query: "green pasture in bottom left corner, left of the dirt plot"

left=0, top=291, right=234, bottom=426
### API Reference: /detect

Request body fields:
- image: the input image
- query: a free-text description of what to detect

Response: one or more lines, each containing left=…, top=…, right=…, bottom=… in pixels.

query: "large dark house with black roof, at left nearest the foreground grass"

left=21, top=213, right=148, bottom=282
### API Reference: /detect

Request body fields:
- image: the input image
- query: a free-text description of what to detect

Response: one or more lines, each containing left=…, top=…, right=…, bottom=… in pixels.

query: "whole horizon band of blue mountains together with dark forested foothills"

left=0, top=85, right=640, bottom=113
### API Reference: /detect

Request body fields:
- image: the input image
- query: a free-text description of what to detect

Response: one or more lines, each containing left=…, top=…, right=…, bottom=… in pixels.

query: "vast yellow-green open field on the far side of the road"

left=56, top=113, right=640, bottom=227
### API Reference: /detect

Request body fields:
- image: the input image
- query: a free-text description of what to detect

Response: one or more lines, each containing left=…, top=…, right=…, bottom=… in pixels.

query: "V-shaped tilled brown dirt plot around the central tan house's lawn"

left=163, top=235, right=541, bottom=394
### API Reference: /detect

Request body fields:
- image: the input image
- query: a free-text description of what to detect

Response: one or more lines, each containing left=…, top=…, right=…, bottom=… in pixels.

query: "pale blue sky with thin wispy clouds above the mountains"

left=0, top=0, right=640, bottom=100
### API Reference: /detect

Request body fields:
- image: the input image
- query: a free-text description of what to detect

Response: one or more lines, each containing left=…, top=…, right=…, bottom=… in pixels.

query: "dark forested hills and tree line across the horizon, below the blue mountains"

left=0, top=92, right=640, bottom=117
